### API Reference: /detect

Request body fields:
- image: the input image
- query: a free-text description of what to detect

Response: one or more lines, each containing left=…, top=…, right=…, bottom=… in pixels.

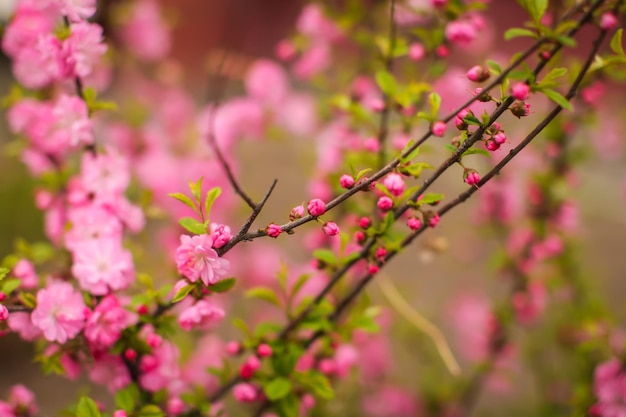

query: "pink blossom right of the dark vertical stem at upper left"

left=62, top=22, right=107, bottom=77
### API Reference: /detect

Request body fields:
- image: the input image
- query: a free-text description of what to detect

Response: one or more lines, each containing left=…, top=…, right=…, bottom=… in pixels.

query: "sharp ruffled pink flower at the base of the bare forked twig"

left=176, top=235, right=230, bottom=285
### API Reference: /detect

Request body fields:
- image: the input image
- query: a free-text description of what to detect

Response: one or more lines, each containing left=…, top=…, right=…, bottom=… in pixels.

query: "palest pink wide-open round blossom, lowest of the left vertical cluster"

left=72, top=239, right=135, bottom=295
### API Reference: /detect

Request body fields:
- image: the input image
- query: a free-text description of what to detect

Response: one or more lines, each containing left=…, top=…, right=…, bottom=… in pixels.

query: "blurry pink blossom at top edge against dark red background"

left=120, top=0, right=172, bottom=61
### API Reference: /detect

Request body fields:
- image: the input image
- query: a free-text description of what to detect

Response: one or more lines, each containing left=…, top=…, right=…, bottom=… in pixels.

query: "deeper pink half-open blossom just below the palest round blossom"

left=85, top=295, right=137, bottom=349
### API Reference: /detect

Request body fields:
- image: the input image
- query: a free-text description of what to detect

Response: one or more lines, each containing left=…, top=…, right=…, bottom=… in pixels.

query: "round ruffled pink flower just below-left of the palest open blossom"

left=31, top=281, right=86, bottom=343
